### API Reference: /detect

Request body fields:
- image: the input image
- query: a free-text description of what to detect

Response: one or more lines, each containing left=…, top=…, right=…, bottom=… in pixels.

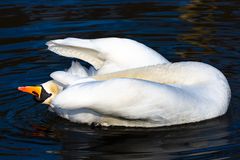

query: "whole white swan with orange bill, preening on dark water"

left=18, top=38, right=231, bottom=127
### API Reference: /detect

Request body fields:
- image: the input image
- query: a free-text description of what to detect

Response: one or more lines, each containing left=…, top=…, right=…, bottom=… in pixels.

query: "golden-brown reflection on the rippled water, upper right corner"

left=179, top=0, right=239, bottom=54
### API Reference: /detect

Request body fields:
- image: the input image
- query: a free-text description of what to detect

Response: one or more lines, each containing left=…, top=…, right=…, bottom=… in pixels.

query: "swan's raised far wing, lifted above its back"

left=47, top=38, right=168, bottom=74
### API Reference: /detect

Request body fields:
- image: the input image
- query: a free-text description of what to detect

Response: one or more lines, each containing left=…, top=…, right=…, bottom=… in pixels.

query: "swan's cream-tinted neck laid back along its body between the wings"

left=94, top=62, right=227, bottom=85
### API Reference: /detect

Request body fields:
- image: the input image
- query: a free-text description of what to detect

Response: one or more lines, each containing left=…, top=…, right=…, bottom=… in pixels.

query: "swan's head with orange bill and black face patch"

left=18, top=81, right=61, bottom=105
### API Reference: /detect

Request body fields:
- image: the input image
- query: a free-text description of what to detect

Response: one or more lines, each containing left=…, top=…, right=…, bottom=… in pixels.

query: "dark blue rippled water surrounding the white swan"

left=0, top=0, right=240, bottom=160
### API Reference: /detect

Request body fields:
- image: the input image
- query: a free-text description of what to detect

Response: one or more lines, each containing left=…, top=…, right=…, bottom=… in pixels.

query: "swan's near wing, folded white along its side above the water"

left=53, top=78, right=199, bottom=123
